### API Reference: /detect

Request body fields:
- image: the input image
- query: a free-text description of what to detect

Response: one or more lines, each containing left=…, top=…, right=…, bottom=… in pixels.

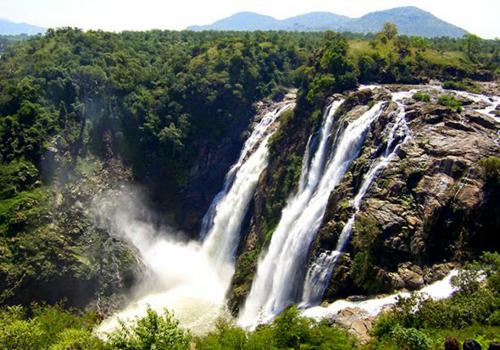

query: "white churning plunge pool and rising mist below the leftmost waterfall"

left=95, top=193, right=226, bottom=337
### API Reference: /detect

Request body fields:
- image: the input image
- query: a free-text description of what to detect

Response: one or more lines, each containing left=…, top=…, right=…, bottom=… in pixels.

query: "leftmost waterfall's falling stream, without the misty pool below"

left=201, top=103, right=293, bottom=278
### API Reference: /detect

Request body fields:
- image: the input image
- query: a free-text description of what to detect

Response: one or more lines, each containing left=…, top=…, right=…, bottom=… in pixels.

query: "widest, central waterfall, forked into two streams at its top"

left=238, top=102, right=384, bottom=327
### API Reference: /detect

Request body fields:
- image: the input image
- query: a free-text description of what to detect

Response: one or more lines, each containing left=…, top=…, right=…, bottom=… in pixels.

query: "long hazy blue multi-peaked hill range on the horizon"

left=187, top=6, right=466, bottom=37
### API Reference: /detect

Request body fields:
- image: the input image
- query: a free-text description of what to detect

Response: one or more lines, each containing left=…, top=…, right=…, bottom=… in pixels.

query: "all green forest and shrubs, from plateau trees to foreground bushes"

left=0, top=23, right=500, bottom=350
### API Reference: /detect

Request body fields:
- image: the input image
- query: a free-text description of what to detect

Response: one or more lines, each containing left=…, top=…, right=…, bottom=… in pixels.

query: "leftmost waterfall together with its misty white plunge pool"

left=96, top=103, right=293, bottom=336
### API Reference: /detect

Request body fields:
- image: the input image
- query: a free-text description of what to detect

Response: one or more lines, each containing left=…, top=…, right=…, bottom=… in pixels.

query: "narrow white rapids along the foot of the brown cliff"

left=302, top=270, right=458, bottom=320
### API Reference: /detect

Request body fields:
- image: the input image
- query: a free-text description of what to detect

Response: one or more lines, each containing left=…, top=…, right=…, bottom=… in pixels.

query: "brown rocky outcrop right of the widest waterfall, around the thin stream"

left=311, top=87, right=500, bottom=300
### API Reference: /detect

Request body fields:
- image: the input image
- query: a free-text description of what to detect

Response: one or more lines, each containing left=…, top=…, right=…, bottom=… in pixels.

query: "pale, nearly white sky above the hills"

left=0, top=0, right=500, bottom=38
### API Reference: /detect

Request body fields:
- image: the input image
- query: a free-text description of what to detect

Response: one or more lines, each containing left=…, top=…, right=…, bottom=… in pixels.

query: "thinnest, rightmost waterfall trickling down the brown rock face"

left=301, top=92, right=411, bottom=307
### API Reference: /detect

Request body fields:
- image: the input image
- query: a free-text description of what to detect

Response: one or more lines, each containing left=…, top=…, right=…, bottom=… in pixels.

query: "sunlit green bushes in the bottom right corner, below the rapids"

left=372, top=253, right=500, bottom=349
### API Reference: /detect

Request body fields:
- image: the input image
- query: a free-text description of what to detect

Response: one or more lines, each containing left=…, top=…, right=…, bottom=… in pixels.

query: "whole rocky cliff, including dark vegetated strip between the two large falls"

left=230, top=86, right=500, bottom=310
